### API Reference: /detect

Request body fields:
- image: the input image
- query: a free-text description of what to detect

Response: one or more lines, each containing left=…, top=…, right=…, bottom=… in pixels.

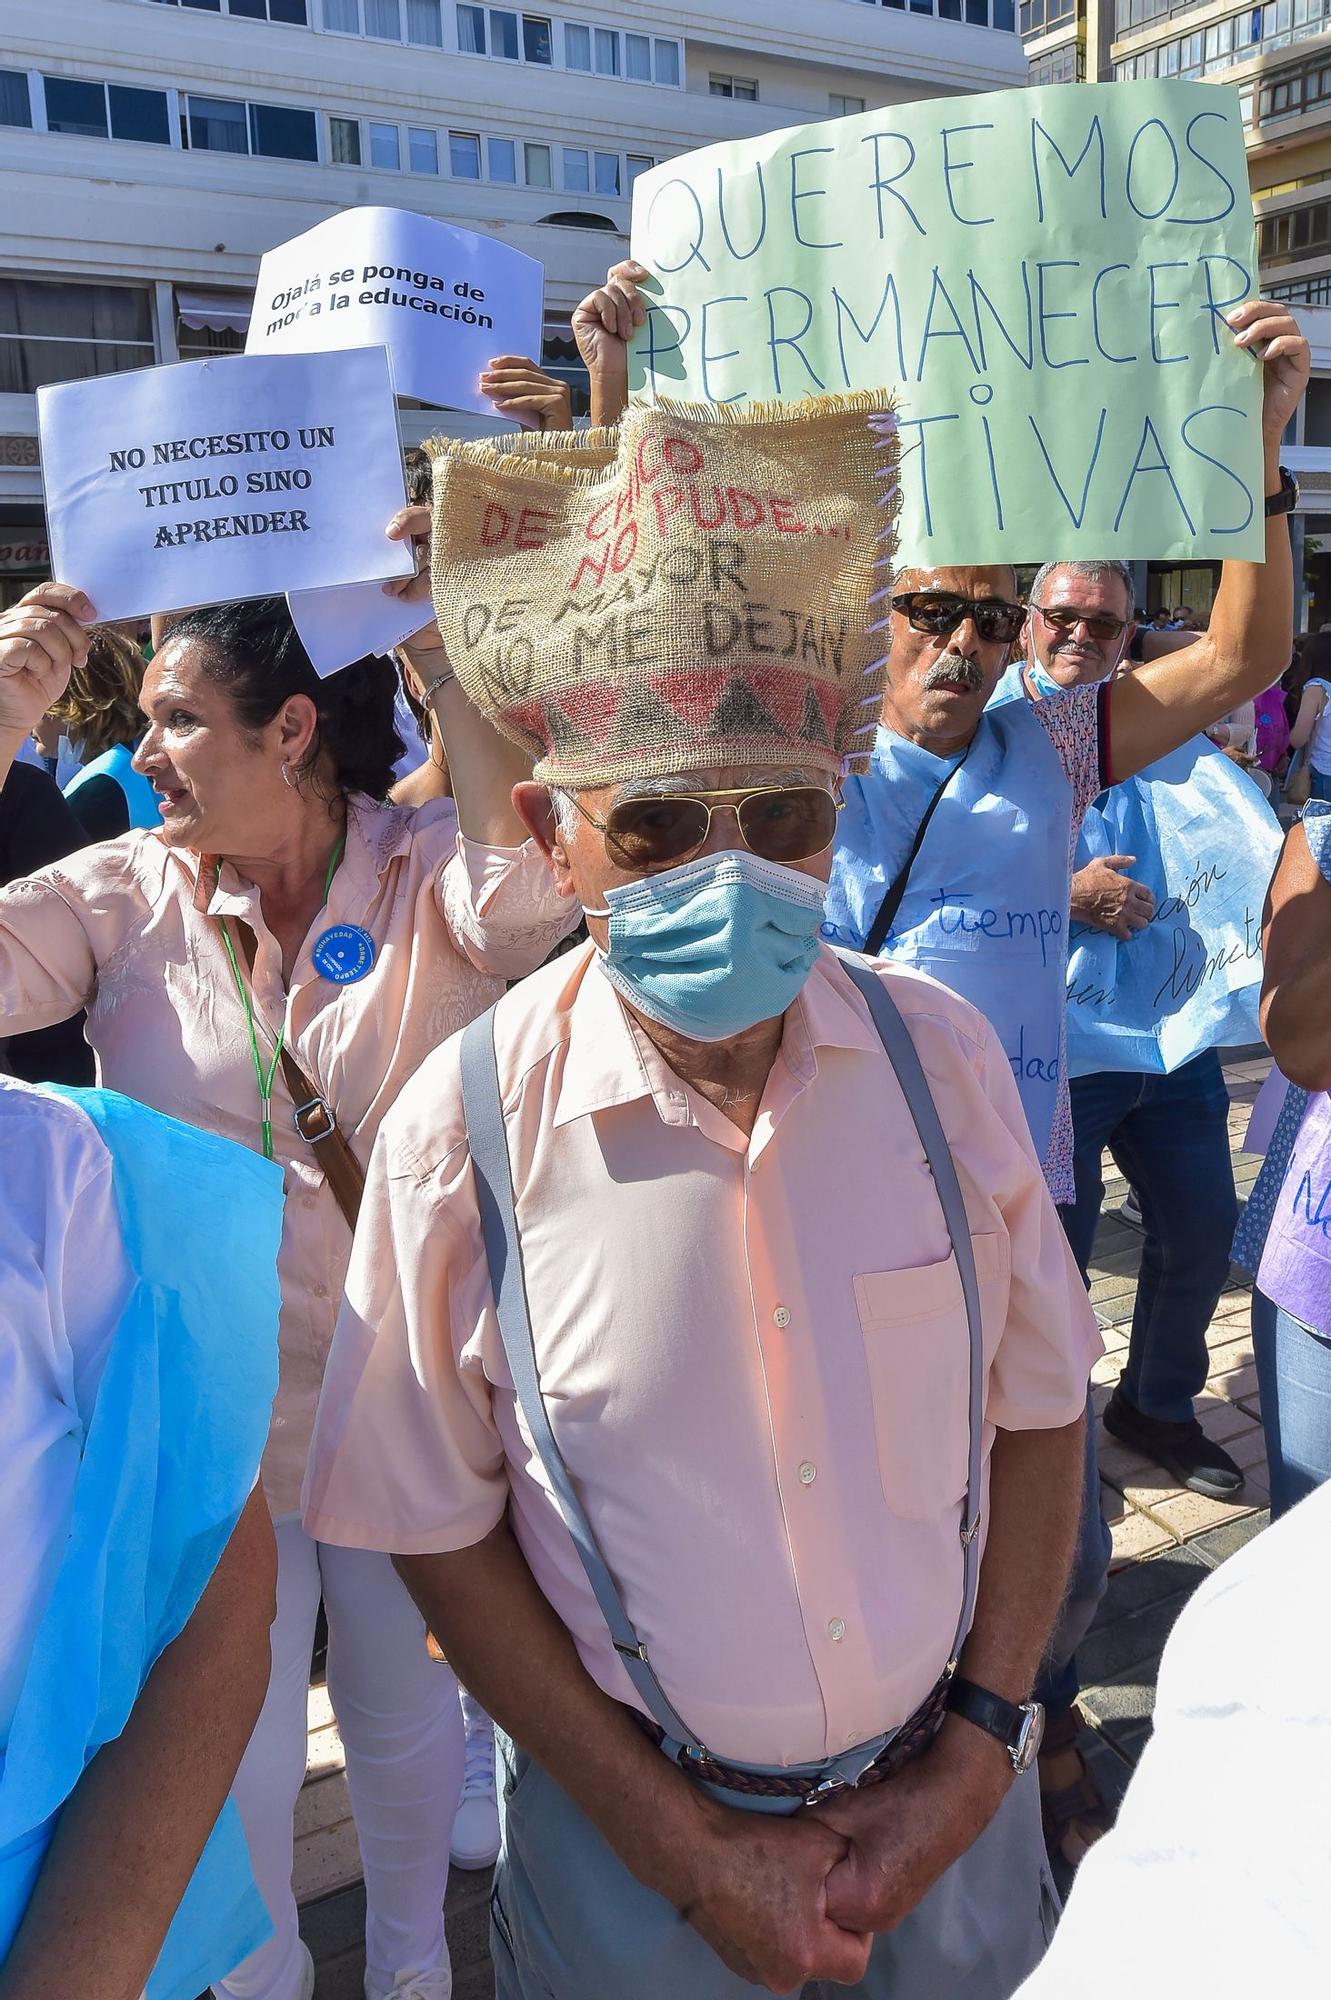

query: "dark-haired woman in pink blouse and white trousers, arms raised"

left=0, top=556, right=570, bottom=2000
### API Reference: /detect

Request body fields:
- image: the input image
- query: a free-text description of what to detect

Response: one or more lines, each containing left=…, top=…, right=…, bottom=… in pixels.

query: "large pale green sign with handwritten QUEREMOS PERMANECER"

left=630, top=82, right=1263, bottom=562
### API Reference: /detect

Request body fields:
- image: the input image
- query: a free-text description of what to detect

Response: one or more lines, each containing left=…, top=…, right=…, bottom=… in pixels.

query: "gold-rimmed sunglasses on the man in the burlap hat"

left=570, top=784, right=843, bottom=868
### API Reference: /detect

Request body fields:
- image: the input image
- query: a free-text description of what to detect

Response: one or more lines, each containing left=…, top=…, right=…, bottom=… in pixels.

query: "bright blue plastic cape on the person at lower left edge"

left=0, top=1090, right=282, bottom=2000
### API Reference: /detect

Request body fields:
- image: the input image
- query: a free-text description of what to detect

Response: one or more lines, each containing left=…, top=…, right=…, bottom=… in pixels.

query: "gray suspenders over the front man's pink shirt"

left=462, top=954, right=983, bottom=1786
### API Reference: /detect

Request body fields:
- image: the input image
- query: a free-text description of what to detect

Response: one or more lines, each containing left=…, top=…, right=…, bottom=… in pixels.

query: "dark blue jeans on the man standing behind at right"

left=1059, top=1050, right=1239, bottom=1424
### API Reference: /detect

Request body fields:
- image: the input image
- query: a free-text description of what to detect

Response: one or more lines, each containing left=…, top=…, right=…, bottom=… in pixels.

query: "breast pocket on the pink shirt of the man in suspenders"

left=855, top=1236, right=1009, bottom=1520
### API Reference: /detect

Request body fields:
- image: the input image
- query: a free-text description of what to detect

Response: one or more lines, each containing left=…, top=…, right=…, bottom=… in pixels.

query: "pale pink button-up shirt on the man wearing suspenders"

left=306, top=948, right=1099, bottom=1764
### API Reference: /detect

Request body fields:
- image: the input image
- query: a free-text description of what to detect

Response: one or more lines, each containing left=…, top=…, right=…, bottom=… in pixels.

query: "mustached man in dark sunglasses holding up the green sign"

left=823, top=300, right=1309, bottom=1868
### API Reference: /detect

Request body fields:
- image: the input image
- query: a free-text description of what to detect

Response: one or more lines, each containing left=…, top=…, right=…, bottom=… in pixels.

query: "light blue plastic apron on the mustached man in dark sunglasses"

left=823, top=712, right=1071, bottom=1160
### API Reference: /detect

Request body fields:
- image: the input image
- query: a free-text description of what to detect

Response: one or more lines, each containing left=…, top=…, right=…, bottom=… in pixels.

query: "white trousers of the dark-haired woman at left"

left=214, top=1518, right=464, bottom=2000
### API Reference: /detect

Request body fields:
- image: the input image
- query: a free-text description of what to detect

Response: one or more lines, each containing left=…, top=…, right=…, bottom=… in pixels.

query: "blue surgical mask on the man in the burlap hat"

left=586, top=848, right=827, bottom=1042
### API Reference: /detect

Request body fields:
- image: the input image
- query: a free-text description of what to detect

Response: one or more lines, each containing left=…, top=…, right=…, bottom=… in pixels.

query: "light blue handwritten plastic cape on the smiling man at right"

left=1067, top=736, right=1281, bottom=1076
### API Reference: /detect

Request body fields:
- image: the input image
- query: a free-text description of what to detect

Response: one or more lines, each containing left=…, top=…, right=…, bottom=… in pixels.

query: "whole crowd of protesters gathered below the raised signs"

left=0, top=264, right=1331, bottom=2000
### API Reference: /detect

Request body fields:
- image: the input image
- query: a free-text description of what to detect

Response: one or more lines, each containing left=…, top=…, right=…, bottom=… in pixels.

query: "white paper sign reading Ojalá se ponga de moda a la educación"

left=246, top=208, right=544, bottom=416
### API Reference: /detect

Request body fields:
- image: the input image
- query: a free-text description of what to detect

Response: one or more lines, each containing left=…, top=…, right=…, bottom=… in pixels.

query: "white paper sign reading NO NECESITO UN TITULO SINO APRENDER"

left=38, top=348, right=412, bottom=620
